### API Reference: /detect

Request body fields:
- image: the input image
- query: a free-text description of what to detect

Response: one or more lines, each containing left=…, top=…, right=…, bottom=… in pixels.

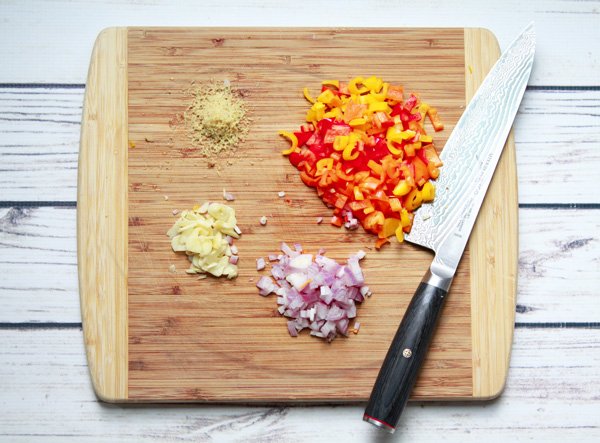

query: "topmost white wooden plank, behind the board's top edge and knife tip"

left=0, top=0, right=600, bottom=85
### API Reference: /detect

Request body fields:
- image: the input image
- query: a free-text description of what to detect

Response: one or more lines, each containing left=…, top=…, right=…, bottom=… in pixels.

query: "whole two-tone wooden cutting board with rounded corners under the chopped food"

left=77, top=28, right=517, bottom=402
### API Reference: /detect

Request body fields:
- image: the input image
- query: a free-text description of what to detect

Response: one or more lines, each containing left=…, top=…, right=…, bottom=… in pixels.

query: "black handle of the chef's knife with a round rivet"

left=363, top=272, right=452, bottom=433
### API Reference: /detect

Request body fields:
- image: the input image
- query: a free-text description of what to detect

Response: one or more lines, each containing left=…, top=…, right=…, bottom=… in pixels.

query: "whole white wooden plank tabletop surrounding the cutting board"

left=0, top=0, right=600, bottom=442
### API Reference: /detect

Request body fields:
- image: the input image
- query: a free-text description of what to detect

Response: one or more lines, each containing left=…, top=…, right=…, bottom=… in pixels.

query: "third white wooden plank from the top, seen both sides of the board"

left=0, top=205, right=600, bottom=325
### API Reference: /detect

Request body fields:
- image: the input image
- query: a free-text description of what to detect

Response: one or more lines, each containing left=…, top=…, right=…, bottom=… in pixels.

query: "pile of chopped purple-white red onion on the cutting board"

left=256, top=245, right=370, bottom=341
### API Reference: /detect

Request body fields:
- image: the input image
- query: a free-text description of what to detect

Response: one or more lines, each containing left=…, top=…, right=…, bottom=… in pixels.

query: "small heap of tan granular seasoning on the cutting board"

left=184, top=81, right=248, bottom=157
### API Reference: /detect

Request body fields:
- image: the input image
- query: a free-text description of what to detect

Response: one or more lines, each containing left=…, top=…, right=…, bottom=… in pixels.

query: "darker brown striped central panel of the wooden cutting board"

left=111, top=29, right=502, bottom=401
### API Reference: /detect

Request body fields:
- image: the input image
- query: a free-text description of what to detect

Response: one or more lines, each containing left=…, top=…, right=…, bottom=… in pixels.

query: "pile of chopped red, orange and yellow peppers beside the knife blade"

left=279, top=76, right=444, bottom=249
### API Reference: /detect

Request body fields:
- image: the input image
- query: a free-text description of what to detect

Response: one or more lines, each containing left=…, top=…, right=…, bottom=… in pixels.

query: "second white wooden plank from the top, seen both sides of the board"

left=0, top=85, right=600, bottom=205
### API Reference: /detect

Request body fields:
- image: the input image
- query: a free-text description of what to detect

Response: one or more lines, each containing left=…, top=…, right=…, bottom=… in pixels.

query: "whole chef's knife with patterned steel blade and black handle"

left=363, top=23, right=535, bottom=432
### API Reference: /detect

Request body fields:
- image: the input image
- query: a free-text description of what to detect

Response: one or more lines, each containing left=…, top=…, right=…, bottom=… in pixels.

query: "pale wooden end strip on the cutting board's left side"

left=77, top=28, right=128, bottom=402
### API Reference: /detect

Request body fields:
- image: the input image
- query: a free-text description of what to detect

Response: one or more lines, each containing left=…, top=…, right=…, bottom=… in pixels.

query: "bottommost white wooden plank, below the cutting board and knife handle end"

left=0, top=328, right=600, bottom=443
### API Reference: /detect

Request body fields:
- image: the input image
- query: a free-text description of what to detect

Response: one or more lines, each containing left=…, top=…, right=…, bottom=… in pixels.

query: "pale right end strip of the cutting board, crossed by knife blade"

left=465, top=28, right=518, bottom=400
